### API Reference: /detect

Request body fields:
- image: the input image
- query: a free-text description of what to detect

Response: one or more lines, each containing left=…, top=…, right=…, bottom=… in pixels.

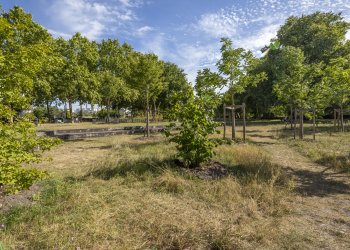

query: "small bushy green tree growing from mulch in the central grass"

left=166, top=69, right=222, bottom=168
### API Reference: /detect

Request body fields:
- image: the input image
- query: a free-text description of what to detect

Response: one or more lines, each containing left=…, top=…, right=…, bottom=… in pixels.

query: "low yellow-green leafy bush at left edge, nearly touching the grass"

left=0, top=105, right=59, bottom=193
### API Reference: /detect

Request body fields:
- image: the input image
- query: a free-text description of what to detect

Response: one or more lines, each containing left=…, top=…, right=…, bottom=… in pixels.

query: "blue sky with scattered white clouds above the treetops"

left=0, top=0, right=350, bottom=82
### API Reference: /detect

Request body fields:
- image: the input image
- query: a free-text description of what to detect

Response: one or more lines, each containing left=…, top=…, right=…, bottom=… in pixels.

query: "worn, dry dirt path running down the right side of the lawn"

left=249, top=127, right=350, bottom=249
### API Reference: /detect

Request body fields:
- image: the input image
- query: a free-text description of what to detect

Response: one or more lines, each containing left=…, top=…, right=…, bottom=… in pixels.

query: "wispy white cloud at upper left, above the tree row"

left=47, top=0, right=139, bottom=39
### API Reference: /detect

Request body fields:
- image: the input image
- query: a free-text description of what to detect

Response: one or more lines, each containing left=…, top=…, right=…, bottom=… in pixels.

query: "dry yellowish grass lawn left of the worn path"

left=0, top=135, right=296, bottom=249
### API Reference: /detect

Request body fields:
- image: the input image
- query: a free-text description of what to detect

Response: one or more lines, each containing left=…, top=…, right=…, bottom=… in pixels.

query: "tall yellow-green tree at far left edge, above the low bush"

left=0, top=6, right=50, bottom=121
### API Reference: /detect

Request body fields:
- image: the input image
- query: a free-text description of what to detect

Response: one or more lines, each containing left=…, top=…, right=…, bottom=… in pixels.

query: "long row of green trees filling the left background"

left=0, top=7, right=190, bottom=125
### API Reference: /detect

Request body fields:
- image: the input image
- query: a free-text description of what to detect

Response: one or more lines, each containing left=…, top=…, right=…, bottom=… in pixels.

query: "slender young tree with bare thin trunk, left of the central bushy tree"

left=132, top=54, right=164, bottom=137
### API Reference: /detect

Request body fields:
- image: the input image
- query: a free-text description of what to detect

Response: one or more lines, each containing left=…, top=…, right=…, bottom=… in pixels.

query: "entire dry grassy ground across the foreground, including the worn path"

left=0, top=123, right=350, bottom=249
